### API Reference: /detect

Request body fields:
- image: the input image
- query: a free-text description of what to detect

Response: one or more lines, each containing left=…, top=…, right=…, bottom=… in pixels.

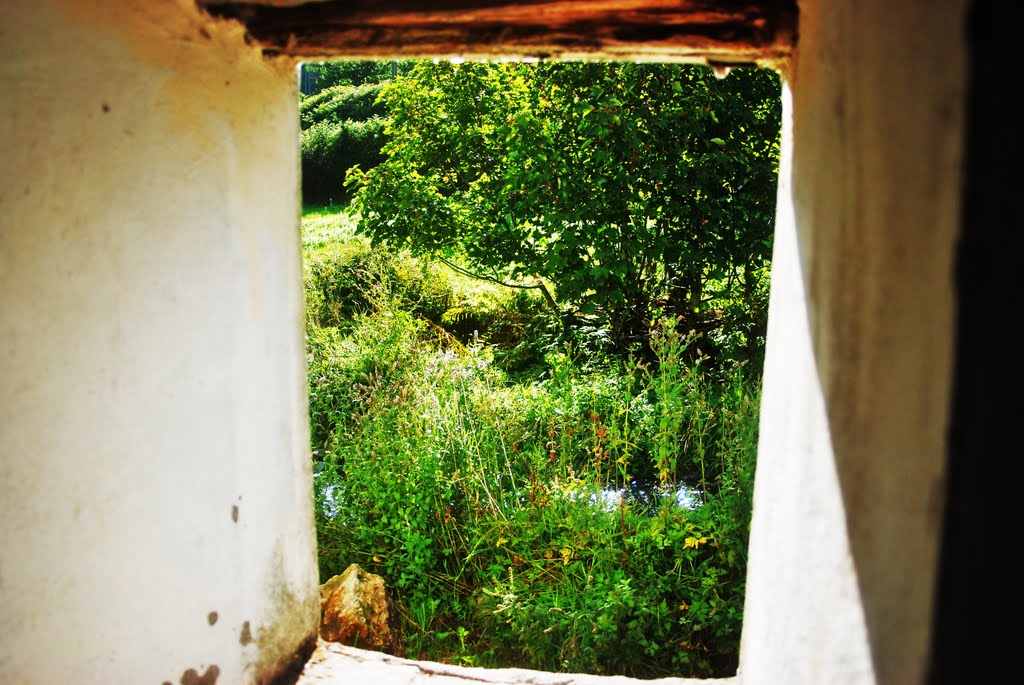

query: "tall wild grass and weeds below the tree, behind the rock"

left=307, top=208, right=759, bottom=677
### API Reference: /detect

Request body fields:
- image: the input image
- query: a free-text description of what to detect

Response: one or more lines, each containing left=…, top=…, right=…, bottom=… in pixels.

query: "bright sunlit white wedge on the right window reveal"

left=739, top=84, right=874, bottom=685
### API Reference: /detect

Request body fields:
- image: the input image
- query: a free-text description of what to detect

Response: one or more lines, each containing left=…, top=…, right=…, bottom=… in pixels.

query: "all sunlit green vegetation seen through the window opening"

left=303, top=60, right=777, bottom=677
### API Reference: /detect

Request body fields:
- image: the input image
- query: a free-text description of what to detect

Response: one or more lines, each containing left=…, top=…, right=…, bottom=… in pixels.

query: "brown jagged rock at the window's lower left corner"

left=319, top=564, right=398, bottom=654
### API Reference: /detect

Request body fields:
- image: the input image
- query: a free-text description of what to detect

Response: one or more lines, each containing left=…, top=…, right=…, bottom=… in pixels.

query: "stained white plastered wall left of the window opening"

left=0, top=0, right=318, bottom=684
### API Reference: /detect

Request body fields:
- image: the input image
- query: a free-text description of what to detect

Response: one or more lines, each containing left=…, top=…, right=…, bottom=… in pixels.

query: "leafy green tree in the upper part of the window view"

left=349, top=62, right=780, bottom=358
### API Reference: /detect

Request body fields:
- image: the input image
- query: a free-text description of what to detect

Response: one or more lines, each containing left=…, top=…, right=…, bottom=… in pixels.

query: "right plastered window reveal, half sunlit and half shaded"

left=739, top=0, right=967, bottom=685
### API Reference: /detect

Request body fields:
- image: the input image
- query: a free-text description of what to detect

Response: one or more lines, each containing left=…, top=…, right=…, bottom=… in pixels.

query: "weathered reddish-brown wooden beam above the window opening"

left=200, top=0, right=797, bottom=65
